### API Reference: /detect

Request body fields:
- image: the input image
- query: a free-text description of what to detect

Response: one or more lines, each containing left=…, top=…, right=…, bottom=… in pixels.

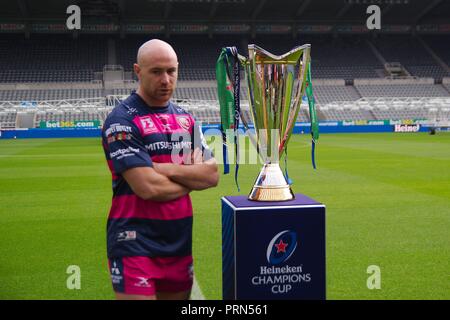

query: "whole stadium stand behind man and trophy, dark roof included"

left=0, top=0, right=450, bottom=128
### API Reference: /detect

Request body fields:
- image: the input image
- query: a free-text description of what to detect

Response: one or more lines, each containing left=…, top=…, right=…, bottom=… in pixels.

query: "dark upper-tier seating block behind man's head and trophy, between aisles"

left=111, top=36, right=383, bottom=80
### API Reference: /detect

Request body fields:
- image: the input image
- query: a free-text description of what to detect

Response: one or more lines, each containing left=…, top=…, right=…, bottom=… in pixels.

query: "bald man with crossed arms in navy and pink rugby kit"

left=102, top=39, right=219, bottom=300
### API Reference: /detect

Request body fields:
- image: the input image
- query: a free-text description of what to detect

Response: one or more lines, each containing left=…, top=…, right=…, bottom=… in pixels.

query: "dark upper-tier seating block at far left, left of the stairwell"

left=0, top=34, right=108, bottom=82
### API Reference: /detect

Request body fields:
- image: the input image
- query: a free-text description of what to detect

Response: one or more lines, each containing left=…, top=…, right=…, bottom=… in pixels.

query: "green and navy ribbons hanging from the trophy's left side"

left=216, top=47, right=240, bottom=191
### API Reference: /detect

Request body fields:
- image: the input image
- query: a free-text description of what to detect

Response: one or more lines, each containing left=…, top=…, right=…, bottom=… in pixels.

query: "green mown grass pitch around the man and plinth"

left=0, top=133, right=450, bottom=299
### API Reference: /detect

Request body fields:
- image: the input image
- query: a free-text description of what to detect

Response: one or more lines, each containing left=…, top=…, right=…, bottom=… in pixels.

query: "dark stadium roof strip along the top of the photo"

left=0, top=0, right=450, bottom=25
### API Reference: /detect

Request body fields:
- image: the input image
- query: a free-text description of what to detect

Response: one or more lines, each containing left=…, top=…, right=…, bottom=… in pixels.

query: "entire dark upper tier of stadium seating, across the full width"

left=0, top=34, right=450, bottom=82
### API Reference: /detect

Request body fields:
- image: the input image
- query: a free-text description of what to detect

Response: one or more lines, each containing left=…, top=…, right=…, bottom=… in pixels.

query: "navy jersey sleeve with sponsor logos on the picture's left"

left=102, top=117, right=153, bottom=174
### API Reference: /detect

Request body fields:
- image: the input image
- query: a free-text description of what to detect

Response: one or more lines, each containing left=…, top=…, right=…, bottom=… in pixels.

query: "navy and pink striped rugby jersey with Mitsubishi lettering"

left=102, top=93, right=212, bottom=258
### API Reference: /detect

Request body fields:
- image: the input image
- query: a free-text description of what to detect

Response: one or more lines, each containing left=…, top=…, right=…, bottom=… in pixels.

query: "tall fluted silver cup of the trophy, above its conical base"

left=244, top=44, right=311, bottom=163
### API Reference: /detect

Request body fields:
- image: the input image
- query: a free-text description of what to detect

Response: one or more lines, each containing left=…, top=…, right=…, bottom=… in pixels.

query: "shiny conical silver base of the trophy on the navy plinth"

left=248, top=163, right=295, bottom=201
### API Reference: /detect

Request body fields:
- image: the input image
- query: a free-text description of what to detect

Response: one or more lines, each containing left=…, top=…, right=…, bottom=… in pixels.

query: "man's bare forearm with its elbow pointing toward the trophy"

left=155, top=161, right=219, bottom=190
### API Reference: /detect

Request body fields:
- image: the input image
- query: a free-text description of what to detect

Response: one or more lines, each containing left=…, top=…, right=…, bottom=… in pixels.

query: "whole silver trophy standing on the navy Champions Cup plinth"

left=238, top=44, right=311, bottom=201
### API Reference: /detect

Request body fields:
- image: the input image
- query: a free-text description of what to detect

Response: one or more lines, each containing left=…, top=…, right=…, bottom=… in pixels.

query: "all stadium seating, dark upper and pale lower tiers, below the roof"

left=0, top=34, right=450, bottom=128
